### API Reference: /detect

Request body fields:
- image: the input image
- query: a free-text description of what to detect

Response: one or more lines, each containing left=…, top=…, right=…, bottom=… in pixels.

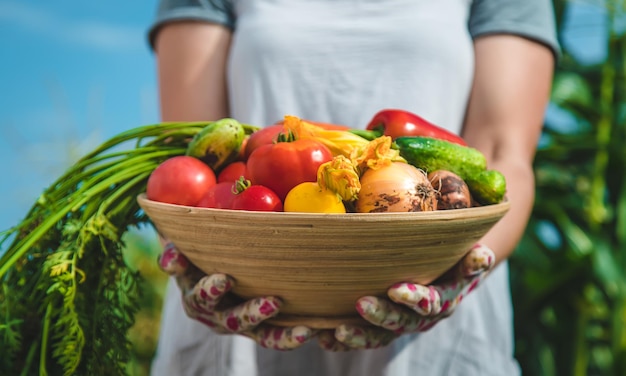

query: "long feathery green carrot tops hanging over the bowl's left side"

left=0, top=123, right=206, bottom=375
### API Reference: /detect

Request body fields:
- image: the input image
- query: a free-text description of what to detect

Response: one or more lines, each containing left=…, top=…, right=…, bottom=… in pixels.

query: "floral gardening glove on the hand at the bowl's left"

left=159, top=243, right=314, bottom=350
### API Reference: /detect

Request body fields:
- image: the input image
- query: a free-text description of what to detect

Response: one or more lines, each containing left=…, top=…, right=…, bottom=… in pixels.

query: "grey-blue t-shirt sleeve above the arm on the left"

left=148, top=0, right=235, bottom=49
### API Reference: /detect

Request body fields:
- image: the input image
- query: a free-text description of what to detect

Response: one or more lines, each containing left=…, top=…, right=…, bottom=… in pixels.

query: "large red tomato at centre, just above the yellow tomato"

left=247, top=139, right=333, bottom=200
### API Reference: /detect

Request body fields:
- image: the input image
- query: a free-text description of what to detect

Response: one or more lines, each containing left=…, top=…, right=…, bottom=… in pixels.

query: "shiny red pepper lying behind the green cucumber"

left=366, top=109, right=467, bottom=146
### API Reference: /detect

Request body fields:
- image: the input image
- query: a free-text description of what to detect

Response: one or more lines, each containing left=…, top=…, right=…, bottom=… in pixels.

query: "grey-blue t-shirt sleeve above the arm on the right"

left=468, top=0, right=561, bottom=57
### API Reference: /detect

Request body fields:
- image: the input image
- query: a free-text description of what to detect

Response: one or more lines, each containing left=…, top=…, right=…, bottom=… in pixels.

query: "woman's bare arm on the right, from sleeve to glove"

left=463, top=35, right=555, bottom=261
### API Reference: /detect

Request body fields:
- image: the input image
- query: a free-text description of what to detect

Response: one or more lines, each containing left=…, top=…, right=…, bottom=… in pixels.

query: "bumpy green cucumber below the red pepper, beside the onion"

left=395, top=136, right=506, bottom=205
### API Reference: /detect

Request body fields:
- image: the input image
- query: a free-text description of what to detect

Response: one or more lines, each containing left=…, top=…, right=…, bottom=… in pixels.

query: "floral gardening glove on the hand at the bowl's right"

left=318, top=244, right=496, bottom=351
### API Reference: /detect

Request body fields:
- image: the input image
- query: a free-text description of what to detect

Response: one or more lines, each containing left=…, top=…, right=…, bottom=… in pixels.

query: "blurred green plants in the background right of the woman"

left=511, top=0, right=626, bottom=376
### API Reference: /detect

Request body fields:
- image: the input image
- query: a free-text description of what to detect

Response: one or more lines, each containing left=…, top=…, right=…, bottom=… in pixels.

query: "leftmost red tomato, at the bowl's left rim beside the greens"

left=146, top=155, right=216, bottom=206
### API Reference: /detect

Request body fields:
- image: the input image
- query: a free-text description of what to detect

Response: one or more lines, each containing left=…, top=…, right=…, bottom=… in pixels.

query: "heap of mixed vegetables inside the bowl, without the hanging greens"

left=147, top=110, right=506, bottom=213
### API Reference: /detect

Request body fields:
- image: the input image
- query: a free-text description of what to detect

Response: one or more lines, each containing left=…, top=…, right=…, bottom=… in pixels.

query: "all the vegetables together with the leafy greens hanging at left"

left=0, top=110, right=506, bottom=375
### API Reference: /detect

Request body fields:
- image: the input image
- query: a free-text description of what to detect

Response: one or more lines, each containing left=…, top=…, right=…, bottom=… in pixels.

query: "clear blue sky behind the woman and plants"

left=0, top=0, right=604, bottom=230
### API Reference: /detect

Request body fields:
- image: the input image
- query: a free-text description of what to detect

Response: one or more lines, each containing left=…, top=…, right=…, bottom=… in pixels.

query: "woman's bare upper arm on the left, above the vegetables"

left=155, top=21, right=231, bottom=121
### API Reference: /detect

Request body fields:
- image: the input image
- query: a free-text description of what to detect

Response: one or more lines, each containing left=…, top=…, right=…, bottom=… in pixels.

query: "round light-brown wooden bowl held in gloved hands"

left=138, top=194, right=509, bottom=328
